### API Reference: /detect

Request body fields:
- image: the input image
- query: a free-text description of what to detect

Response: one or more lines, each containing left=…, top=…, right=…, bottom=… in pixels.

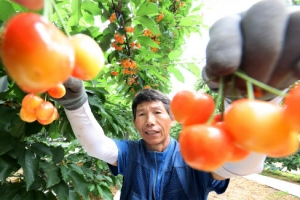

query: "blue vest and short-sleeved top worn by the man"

left=109, top=138, right=229, bottom=200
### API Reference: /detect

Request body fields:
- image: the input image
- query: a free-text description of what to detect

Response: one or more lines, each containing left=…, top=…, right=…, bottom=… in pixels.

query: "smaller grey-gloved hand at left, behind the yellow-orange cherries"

left=54, top=77, right=88, bottom=110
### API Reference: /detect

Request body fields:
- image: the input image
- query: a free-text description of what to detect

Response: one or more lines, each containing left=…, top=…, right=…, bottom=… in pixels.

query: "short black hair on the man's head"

left=131, top=88, right=173, bottom=120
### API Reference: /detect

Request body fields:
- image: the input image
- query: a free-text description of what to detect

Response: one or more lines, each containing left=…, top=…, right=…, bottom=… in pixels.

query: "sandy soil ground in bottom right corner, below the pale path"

left=208, top=177, right=300, bottom=200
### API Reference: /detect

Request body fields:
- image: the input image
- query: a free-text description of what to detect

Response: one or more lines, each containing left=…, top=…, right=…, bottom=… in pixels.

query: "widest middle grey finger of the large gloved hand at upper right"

left=240, top=0, right=288, bottom=83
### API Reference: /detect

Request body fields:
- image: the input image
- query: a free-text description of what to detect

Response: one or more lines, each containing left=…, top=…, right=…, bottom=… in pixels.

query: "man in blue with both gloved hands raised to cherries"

left=38, top=0, right=300, bottom=200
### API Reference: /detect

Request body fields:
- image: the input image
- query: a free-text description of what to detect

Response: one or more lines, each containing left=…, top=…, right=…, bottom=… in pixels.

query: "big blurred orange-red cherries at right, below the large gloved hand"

left=171, top=85, right=300, bottom=171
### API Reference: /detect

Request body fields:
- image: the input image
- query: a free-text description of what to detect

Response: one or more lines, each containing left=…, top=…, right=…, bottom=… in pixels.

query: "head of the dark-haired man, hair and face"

left=132, top=89, right=174, bottom=152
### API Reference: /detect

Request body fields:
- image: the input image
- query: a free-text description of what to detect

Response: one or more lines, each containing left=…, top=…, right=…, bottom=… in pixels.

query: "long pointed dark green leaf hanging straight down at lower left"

left=18, top=149, right=38, bottom=190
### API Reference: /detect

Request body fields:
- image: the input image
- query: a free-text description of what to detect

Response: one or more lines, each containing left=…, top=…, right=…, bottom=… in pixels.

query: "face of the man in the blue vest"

left=134, top=101, right=173, bottom=151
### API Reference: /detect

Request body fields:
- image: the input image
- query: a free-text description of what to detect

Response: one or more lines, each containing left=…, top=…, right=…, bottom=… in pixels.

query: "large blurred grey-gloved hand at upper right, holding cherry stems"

left=202, top=0, right=300, bottom=100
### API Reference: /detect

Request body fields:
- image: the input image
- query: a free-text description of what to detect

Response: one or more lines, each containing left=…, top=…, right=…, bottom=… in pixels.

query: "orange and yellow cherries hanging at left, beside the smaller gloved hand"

left=0, top=0, right=105, bottom=125
